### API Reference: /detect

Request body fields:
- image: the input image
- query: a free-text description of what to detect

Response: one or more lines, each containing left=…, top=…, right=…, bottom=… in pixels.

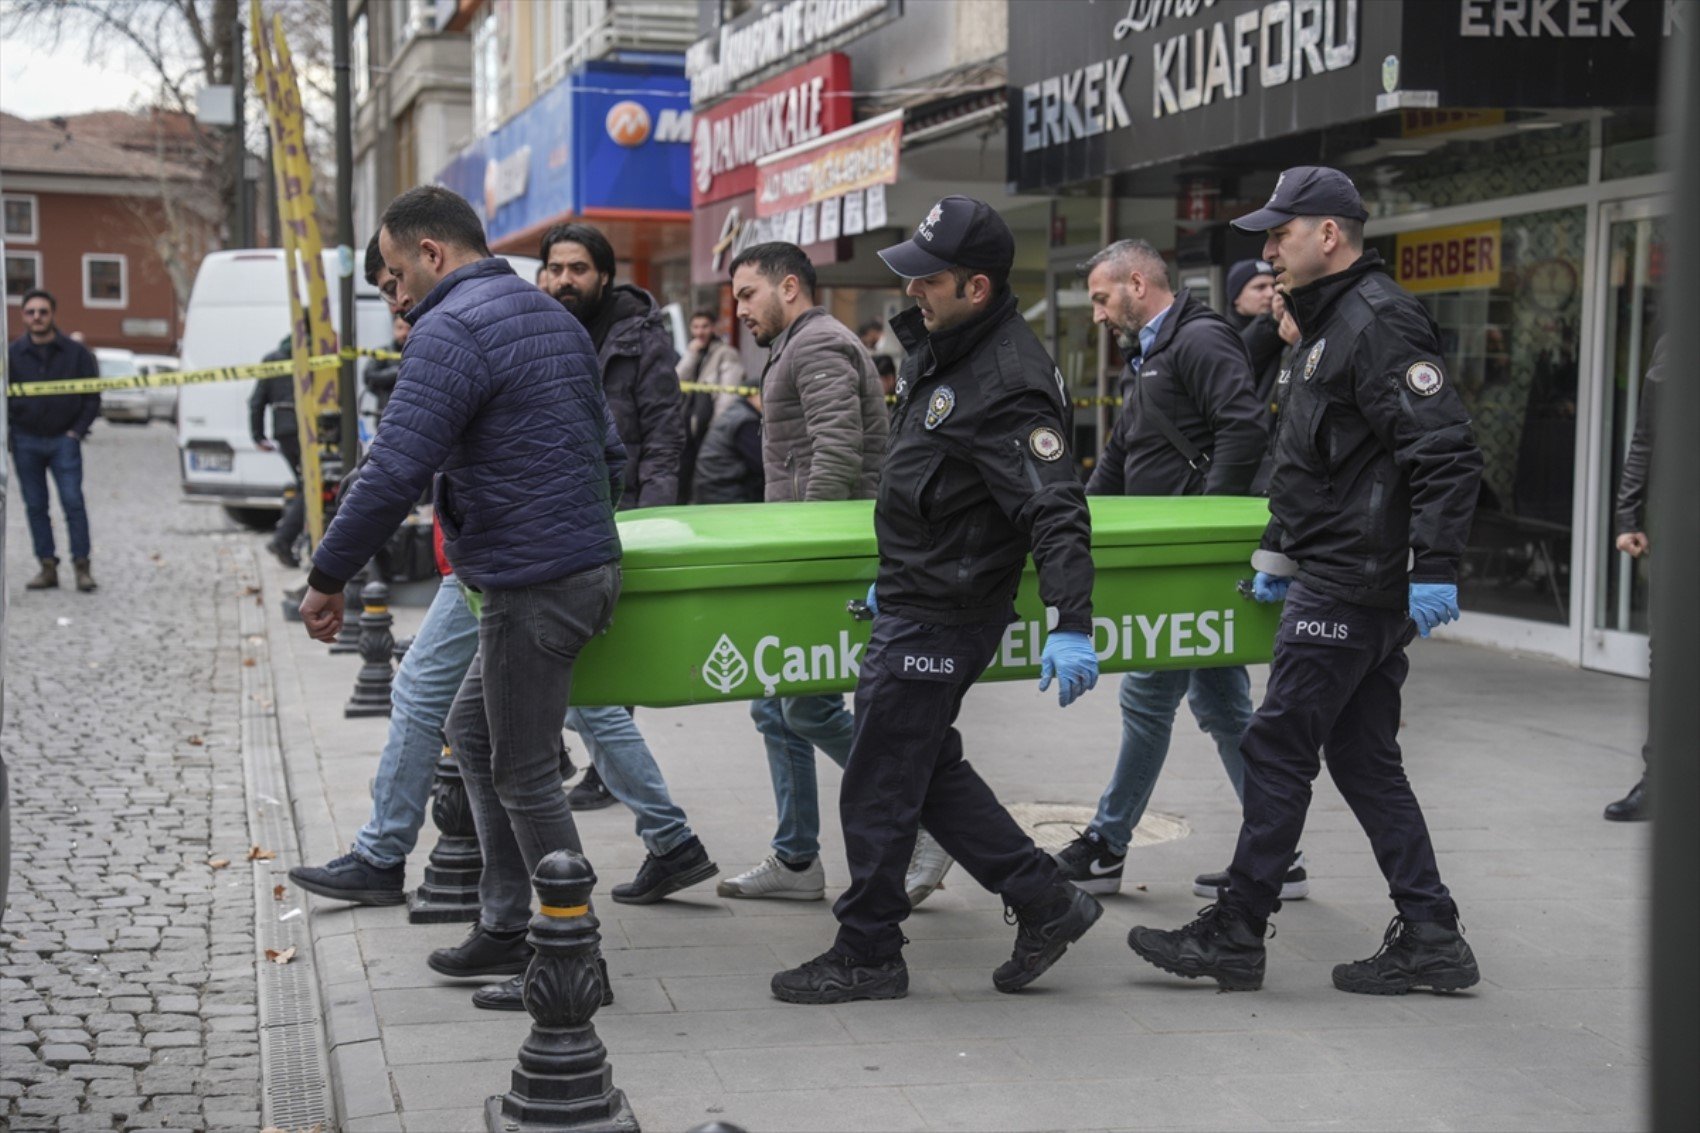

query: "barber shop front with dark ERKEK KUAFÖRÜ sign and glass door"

left=1006, top=0, right=1695, bottom=674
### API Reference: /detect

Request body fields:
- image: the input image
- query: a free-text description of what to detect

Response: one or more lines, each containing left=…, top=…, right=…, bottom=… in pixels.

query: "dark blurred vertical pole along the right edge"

left=1647, top=13, right=1700, bottom=1131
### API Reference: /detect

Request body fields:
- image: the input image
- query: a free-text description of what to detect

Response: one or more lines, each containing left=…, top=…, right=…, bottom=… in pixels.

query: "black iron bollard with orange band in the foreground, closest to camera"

left=485, top=851, right=638, bottom=1133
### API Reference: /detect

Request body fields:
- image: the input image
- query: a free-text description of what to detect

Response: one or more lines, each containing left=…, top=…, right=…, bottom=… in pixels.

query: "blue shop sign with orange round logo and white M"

left=437, top=63, right=690, bottom=242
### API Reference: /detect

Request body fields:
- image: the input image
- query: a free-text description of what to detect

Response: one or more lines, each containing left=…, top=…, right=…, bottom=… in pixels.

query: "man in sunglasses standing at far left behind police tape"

left=7, top=288, right=100, bottom=592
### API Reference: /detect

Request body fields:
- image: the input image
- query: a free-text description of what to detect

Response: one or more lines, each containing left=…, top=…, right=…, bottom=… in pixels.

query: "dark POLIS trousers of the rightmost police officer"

left=1226, top=582, right=1457, bottom=920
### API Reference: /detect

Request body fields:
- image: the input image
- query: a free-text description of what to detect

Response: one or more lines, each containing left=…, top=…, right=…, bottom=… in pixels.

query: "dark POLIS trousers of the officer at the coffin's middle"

left=833, top=614, right=1063, bottom=959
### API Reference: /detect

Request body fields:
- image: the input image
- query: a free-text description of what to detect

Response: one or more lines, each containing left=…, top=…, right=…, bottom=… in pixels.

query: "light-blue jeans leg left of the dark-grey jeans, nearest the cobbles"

left=354, top=575, right=478, bottom=866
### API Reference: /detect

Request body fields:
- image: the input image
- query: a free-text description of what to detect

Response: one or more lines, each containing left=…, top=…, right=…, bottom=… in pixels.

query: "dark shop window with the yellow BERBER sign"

left=1369, top=208, right=1586, bottom=624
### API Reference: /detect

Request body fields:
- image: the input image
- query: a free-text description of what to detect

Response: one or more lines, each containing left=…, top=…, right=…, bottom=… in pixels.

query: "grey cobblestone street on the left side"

left=0, top=422, right=260, bottom=1133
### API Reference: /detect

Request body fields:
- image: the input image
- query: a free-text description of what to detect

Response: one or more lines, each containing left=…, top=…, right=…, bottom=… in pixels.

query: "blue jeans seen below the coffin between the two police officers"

left=1091, top=665, right=1251, bottom=854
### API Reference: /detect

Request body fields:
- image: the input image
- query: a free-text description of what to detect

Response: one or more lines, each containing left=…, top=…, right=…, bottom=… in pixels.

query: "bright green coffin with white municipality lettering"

left=573, top=497, right=1280, bottom=708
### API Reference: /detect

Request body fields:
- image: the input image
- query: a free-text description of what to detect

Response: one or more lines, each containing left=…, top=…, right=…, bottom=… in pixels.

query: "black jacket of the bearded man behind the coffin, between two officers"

left=1086, top=291, right=1268, bottom=495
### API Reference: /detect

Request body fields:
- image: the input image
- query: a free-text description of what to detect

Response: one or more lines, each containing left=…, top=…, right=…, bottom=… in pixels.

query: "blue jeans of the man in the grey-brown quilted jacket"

left=750, top=696, right=855, bottom=864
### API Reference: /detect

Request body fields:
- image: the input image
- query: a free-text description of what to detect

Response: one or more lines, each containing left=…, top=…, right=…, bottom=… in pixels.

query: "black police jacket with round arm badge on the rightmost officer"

left=1251, top=252, right=1482, bottom=609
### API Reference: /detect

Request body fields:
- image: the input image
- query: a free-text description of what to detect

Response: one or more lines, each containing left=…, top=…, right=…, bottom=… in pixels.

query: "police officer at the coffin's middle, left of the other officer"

left=774, top=196, right=1103, bottom=1004
